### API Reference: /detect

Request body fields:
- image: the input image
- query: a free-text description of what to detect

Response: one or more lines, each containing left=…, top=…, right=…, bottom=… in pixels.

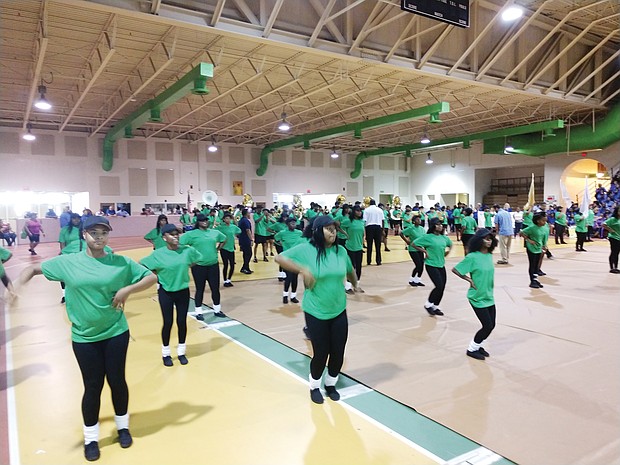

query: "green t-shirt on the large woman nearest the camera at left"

left=41, top=251, right=151, bottom=342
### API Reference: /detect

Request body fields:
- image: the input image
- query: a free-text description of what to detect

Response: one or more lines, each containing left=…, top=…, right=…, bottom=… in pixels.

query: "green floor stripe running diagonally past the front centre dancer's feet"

left=205, top=314, right=514, bottom=465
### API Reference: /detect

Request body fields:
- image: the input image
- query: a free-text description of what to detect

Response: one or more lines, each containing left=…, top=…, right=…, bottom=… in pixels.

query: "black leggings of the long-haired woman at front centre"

left=304, top=310, right=349, bottom=379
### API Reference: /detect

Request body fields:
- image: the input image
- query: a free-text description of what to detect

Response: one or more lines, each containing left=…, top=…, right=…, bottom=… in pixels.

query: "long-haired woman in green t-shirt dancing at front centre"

left=276, top=215, right=361, bottom=404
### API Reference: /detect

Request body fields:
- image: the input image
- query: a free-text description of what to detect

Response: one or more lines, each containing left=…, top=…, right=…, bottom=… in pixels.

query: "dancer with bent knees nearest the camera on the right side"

left=452, top=229, right=497, bottom=360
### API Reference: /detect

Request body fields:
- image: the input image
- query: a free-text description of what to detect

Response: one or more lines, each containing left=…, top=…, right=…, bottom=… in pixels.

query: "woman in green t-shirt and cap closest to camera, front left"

left=19, top=216, right=157, bottom=461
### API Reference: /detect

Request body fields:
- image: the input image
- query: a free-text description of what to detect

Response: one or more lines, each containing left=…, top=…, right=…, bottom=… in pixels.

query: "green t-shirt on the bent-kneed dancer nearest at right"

left=454, top=252, right=495, bottom=308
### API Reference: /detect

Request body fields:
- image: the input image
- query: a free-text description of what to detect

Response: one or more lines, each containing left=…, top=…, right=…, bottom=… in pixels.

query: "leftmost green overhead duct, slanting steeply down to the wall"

left=103, top=63, right=213, bottom=171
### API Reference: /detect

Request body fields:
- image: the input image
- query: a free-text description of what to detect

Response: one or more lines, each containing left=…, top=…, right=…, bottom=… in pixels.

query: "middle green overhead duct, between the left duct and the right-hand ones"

left=256, top=102, right=450, bottom=176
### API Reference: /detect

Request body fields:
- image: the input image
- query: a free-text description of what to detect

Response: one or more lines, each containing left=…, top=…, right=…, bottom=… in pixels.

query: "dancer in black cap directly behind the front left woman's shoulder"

left=140, top=224, right=202, bottom=367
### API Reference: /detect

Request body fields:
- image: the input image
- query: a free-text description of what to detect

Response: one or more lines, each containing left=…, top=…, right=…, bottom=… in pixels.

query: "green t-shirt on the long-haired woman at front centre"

left=282, top=242, right=353, bottom=320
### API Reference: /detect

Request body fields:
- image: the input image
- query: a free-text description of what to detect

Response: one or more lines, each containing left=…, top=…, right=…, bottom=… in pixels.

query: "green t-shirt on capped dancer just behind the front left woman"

left=140, top=245, right=202, bottom=292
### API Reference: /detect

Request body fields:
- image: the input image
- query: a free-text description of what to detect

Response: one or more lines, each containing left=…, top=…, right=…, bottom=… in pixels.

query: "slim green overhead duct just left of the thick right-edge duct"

left=351, top=119, right=564, bottom=179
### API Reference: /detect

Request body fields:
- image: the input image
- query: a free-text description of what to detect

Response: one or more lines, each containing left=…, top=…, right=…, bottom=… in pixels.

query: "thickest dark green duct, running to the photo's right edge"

left=484, top=104, right=620, bottom=157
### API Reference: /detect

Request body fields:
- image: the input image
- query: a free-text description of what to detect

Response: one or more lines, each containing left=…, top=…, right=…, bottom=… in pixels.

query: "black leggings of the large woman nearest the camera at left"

left=73, top=331, right=129, bottom=426
